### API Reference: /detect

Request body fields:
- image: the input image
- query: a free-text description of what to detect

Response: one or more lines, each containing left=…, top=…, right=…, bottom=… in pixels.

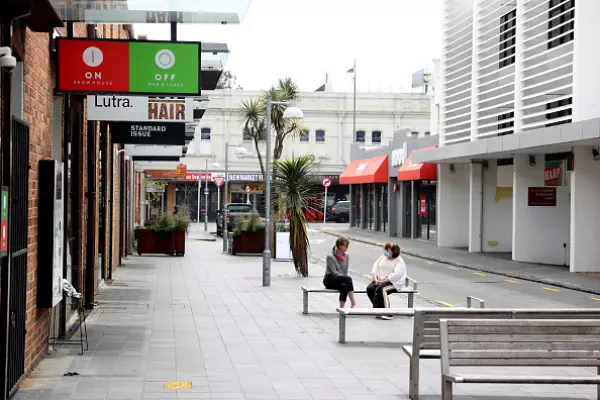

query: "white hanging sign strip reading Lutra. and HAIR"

left=87, top=95, right=194, bottom=122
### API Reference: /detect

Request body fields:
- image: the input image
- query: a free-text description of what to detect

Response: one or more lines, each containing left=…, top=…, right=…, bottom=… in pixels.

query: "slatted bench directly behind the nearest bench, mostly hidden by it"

left=402, top=308, right=600, bottom=400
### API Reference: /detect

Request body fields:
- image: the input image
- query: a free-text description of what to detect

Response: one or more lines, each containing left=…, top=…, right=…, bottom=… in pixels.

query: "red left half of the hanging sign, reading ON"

left=57, top=40, right=129, bottom=93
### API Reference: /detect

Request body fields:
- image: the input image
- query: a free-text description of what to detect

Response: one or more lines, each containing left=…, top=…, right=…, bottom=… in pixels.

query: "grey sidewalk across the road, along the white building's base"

left=311, top=225, right=600, bottom=295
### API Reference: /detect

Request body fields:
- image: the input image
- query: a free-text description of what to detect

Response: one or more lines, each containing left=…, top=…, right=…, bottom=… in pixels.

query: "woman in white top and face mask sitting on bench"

left=367, top=243, right=406, bottom=319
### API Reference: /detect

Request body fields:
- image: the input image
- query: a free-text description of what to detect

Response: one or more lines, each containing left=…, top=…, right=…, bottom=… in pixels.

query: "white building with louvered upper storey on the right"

left=415, top=0, right=600, bottom=272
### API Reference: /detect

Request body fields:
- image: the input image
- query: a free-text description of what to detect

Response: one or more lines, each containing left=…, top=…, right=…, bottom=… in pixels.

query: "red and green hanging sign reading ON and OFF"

left=56, top=38, right=201, bottom=96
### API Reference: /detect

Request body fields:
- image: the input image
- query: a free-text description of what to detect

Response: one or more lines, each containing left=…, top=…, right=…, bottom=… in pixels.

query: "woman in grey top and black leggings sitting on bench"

left=323, top=237, right=356, bottom=308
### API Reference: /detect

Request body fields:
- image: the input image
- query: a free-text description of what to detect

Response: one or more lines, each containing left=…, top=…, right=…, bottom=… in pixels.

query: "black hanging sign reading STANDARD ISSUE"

left=111, top=122, right=185, bottom=146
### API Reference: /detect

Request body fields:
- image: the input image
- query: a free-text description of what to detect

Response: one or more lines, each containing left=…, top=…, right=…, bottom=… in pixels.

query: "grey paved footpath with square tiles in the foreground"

left=15, top=240, right=595, bottom=400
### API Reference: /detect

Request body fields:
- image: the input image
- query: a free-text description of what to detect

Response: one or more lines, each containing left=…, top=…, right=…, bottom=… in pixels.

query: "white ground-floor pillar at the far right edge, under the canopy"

left=570, top=147, right=600, bottom=272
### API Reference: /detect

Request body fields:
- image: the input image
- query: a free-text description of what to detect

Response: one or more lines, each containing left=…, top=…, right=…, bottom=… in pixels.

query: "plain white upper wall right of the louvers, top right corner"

left=573, top=0, right=600, bottom=121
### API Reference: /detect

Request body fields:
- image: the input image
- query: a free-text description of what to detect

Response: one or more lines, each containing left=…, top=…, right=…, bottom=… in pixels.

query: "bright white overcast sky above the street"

left=134, top=0, right=442, bottom=93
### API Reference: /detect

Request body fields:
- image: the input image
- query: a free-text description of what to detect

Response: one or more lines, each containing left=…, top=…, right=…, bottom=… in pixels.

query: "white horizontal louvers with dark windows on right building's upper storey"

left=440, top=0, right=576, bottom=146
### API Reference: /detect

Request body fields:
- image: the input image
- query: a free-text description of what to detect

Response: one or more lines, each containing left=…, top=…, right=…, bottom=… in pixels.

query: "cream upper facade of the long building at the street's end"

left=183, top=90, right=431, bottom=173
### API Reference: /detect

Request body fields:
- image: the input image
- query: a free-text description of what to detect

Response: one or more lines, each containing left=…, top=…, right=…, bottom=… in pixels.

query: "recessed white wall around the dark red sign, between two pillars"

left=513, top=155, right=571, bottom=265
